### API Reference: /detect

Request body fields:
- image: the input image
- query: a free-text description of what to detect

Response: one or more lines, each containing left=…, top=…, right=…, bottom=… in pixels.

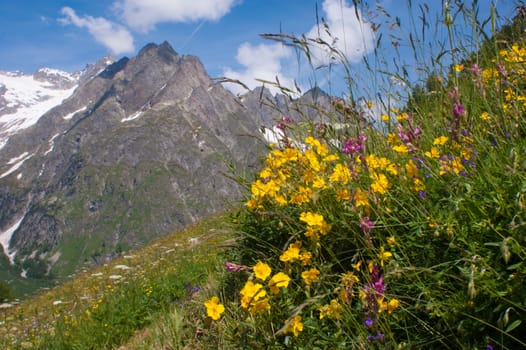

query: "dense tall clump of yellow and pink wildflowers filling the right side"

left=206, top=3, right=526, bottom=349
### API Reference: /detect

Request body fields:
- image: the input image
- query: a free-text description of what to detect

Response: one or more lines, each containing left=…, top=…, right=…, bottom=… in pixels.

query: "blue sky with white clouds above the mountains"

left=0, top=0, right=517, bottom=96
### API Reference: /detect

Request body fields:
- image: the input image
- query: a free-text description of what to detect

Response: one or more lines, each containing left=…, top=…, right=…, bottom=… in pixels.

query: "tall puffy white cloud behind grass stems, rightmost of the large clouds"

left=306, top=0, right=374, bottom=66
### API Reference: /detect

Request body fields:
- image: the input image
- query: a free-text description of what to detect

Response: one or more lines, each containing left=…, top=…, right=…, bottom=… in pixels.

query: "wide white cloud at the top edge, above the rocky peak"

left=114, top=0, right=238, bottom=32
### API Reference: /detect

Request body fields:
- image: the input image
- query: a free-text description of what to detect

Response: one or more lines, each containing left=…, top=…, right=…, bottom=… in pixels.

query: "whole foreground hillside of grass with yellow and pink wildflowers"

left=0, top=2, right=526, bottom=350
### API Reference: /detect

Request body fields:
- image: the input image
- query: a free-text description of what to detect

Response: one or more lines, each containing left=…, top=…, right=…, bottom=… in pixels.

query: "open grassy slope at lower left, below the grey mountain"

left=0, top=216, right=237, bottom=349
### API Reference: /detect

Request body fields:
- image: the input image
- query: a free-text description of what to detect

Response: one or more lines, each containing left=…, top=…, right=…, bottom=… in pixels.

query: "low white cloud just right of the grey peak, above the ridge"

left=224, top=43, right=294, bottom=94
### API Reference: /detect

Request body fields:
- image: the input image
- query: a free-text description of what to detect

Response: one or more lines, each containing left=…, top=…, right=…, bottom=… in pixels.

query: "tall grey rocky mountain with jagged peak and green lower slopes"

left=0, top=42, right=263, bottom=288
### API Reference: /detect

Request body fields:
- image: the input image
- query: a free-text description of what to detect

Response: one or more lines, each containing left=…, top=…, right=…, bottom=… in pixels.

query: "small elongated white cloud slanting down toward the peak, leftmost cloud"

left=60, top=7, right=135, bottom=55
